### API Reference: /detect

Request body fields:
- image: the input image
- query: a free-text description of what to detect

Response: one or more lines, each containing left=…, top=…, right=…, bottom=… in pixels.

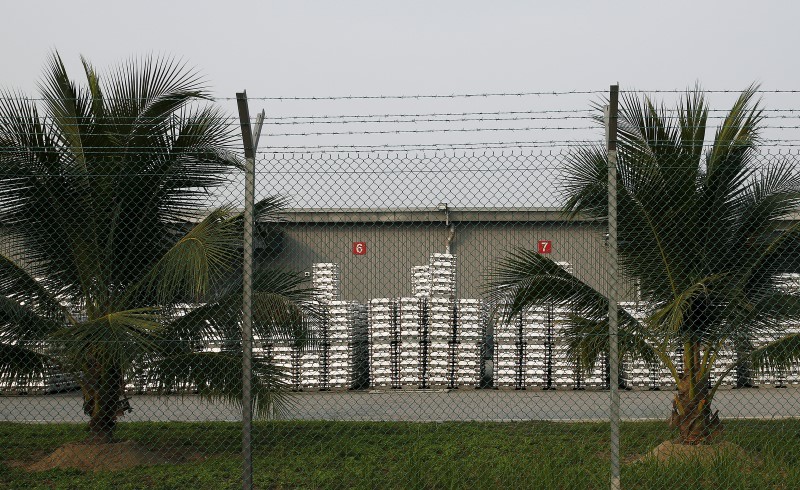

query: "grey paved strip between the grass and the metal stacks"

left=0, top=387, right=800, bottom=423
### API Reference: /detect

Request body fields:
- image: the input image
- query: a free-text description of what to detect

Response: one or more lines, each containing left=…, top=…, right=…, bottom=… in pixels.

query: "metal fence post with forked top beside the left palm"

left=236, top=92, right=255, bottom=490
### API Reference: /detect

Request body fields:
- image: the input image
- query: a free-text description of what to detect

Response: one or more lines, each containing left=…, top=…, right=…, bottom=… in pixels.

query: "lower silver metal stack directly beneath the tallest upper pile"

left=427, top=297, right=455, bottom=387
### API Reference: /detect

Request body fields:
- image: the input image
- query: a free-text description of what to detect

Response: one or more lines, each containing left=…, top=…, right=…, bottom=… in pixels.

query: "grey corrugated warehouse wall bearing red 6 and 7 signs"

left=262, top=203, right=620, bottom=303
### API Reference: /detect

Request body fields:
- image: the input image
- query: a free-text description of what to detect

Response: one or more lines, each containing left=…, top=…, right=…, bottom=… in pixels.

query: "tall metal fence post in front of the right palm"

left=606, top=85, right=620, bottom=490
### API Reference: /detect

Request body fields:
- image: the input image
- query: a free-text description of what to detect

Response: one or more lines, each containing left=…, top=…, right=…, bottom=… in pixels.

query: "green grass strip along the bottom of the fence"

left=0, top=420, right=800, bottom=490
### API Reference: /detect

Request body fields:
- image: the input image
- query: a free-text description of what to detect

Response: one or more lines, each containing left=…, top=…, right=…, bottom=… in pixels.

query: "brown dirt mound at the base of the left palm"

left=22, top=441, right=202, bottom=471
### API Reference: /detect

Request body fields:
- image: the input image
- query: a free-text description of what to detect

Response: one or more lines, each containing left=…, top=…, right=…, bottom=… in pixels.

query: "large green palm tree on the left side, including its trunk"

left=0, top=53, right=314, bottom=442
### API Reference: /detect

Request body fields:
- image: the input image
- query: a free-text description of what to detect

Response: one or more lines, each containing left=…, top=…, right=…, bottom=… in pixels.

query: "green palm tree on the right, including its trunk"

left=492, top=87, right=800, bottom=444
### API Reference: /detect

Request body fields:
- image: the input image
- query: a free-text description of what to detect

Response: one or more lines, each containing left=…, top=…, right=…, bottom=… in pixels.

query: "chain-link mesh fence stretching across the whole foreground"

left=0, top=63, right=800, bottom=488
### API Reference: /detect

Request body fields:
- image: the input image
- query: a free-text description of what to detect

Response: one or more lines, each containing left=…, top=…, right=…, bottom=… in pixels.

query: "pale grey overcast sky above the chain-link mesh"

left=0, top=0, right=800, bottom=207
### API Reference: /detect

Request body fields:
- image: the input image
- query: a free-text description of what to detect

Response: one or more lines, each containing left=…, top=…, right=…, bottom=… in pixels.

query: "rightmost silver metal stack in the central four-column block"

left=454, top=299, right=486, bottom=387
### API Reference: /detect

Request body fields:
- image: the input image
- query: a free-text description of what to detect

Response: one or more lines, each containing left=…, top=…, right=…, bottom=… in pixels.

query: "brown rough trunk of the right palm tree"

left=669, top=345, right=722, bottom=444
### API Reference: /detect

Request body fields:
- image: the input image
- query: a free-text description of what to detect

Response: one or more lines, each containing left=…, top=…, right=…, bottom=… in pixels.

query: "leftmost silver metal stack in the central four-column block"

left=369, top=298, right=399, bottom=386
